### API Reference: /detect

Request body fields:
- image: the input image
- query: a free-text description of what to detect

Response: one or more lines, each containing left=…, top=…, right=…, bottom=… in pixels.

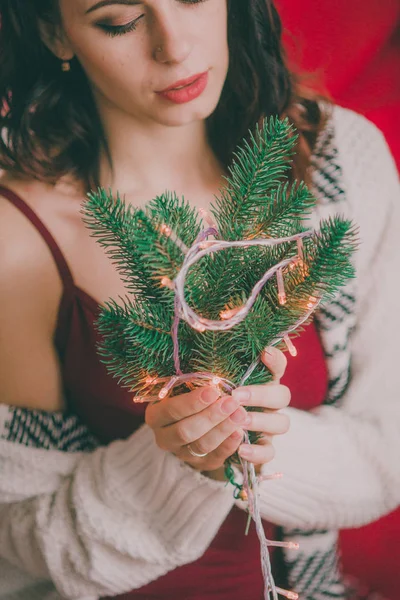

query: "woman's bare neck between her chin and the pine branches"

left=95, top=98, right=223, bottom=200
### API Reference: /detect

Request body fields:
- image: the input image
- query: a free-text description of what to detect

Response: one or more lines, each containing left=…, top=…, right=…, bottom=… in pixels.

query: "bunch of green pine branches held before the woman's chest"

left=83, top=118, right=357, bottom=410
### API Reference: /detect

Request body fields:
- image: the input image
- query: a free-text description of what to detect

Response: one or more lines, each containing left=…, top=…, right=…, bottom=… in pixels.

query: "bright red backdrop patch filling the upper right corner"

left=277, top=0, right=400, bottom=169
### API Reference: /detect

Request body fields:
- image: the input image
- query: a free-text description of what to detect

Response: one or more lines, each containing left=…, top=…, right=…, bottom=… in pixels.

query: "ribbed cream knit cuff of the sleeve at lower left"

left=92, top=425, right=234, bottom=563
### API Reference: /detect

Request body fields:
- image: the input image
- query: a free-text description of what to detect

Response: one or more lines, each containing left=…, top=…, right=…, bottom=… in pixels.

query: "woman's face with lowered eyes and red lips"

left=59, top=0, right=229, bottom=126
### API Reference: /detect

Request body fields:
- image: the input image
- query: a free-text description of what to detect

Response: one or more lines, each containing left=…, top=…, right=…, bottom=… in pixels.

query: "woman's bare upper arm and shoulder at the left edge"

left=0, top=171, right=62, bottom=410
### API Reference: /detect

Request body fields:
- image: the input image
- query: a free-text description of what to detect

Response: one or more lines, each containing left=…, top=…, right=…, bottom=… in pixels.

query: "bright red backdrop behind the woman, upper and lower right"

left=277, top=0, right=400, bottom=600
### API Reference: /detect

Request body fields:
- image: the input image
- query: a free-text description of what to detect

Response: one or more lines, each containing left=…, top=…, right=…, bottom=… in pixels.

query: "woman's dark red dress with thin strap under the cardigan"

left=0, top=187, right=328, bottom=600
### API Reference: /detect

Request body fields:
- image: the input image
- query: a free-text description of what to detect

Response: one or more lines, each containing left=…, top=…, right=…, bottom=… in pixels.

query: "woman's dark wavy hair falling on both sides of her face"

left=0, top=0, right=324, bottom=189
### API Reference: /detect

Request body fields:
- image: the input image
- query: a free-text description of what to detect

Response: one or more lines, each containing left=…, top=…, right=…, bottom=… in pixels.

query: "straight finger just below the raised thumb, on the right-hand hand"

left=232, top=382, right=291, bottom=410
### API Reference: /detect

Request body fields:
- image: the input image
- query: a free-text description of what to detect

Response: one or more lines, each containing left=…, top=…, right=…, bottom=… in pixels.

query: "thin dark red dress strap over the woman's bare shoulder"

left=0, top=185, right=74, bottom=288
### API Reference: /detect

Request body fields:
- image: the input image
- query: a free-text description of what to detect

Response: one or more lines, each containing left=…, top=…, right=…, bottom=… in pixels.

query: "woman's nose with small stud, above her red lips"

left=153, top=4, right=193, bottom=63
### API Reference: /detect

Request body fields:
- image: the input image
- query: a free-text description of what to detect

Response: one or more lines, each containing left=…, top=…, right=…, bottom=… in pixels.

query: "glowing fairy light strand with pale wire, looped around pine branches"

left=135, top=209, right=321, bottom=600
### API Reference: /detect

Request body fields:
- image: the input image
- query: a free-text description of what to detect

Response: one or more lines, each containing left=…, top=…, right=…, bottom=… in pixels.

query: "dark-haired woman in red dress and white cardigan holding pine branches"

left=0, top=0, right=400, bottom=600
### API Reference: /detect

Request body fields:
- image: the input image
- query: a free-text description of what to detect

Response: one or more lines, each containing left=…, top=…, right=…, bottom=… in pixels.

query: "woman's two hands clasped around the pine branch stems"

left=146, top=348, right=290, bottom=479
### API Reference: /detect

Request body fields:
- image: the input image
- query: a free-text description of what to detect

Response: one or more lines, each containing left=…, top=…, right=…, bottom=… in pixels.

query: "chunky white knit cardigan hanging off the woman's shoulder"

left=0, top=107, right=400, bottom=600
